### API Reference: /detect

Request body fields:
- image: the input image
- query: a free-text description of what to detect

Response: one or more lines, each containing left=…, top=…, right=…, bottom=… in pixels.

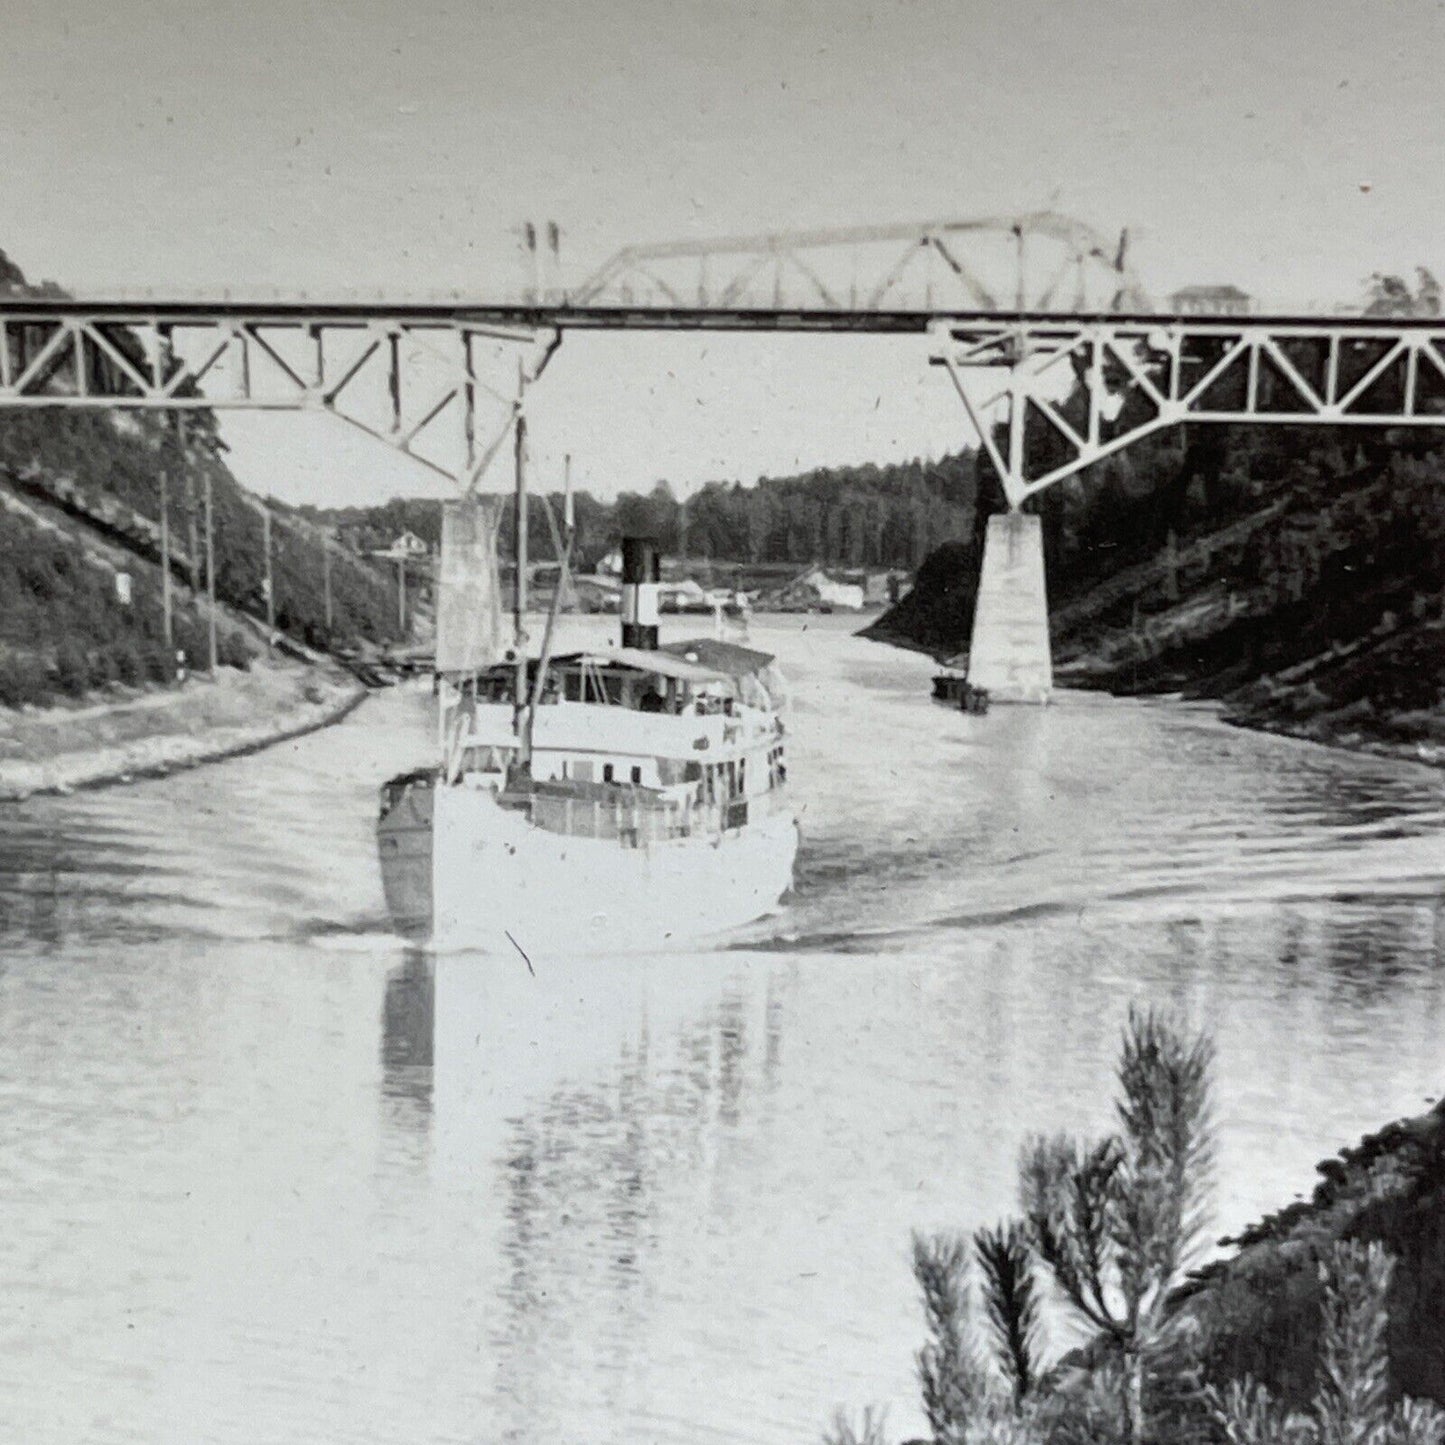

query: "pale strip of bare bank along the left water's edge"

left=0, top=659, right=367, bottom=801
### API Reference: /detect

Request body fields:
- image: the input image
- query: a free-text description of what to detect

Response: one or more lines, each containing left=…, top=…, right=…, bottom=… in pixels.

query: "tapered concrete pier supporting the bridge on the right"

left=968, top=512, right=1053, bottom=702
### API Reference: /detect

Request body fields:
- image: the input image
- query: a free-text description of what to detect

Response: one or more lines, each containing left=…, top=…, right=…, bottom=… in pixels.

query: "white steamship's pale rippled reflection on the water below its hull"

left=381, top=954, right=789, bottom=1442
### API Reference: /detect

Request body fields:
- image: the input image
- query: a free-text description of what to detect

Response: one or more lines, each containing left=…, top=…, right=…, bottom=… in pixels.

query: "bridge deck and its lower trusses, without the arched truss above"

left=0, top=293, right=1445, bottom=507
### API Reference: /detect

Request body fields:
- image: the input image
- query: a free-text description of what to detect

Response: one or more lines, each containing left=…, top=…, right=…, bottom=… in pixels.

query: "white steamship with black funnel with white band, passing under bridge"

left=379, top=525, right=798, bottom=957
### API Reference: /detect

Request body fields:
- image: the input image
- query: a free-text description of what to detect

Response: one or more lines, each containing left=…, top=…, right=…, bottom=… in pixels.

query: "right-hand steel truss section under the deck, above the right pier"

left=929, top=316, right=1445, bottom=507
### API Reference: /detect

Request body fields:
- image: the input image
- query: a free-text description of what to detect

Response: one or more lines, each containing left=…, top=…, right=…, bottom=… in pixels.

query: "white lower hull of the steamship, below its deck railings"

left=380, top=782, right=798, bottom=954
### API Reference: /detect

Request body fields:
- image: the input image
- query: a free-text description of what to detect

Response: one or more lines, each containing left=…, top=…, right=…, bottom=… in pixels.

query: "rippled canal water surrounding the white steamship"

left=0, top=618, right=1445, bottom=1445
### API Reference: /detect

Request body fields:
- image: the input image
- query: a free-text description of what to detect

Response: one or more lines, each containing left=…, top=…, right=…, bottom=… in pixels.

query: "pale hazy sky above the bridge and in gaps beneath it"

left=0, top=0, right=1445, bottom=503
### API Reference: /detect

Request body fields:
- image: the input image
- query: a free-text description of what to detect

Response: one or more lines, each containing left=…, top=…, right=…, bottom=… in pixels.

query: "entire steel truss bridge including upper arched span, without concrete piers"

left=0, top=212, right=1445, bottom=509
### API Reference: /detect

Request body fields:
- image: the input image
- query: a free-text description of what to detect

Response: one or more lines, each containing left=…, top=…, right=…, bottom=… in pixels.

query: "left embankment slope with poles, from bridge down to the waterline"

left=0, top=253, right=410, bottom=796
